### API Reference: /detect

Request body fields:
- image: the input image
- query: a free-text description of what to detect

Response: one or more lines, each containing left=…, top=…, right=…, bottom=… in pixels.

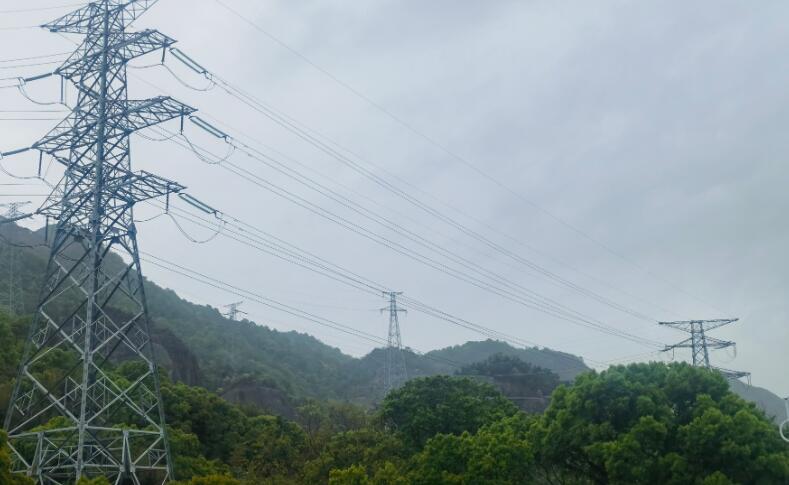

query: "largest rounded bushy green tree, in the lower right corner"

left=529, top=363, right=789, bottom=485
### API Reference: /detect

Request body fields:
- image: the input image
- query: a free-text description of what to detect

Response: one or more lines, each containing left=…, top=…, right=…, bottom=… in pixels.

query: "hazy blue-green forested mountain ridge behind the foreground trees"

left=0, top=220, right=785, bottom=417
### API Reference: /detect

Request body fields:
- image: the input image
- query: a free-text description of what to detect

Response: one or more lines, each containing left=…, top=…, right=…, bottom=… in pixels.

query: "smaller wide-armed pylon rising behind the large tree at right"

left=660, top=318, right=751, bottom=379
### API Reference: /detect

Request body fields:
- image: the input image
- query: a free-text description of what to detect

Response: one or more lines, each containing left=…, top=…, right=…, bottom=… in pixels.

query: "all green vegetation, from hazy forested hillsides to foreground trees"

left=0, top=225, right=789, bottom=485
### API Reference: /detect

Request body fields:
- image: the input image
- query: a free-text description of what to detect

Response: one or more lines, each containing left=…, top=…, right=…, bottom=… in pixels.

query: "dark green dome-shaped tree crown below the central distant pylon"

left=380, top=376, right=518, bottom=450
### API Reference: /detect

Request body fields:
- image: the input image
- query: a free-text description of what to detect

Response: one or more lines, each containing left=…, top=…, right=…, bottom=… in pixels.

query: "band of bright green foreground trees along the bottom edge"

left=0, top=354, right=789, bottom=485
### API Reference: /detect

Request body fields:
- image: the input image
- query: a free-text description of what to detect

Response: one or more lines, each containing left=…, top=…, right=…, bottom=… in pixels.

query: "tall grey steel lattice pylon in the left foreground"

left=5, top=0, right=194, bottom=485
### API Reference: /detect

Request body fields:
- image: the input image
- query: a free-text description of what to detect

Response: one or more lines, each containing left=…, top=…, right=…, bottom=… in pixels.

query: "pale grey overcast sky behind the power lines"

left=0, top=0, right=789, bottom=395
